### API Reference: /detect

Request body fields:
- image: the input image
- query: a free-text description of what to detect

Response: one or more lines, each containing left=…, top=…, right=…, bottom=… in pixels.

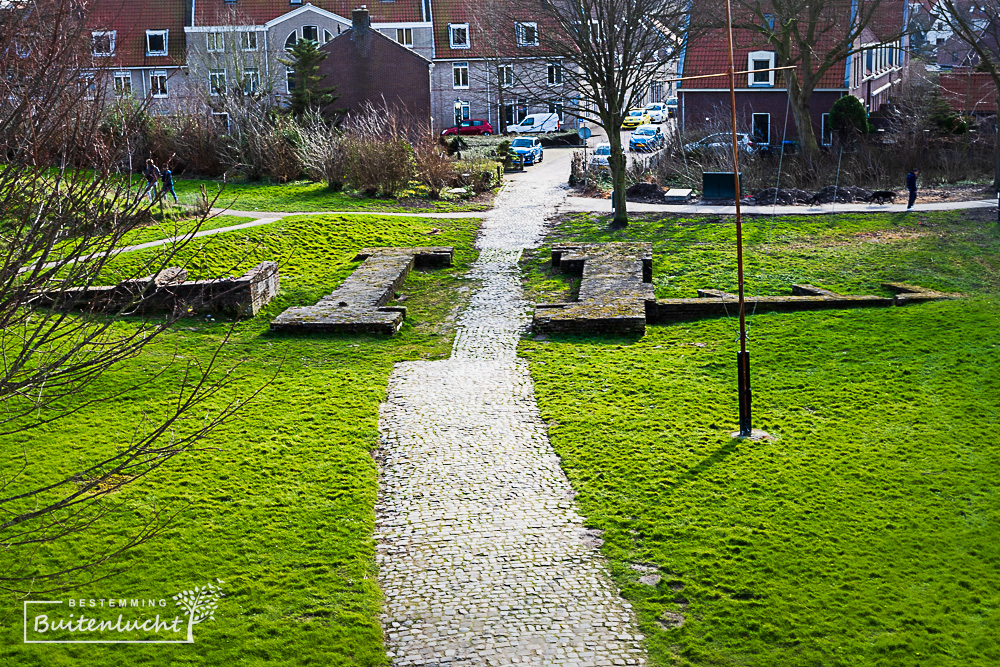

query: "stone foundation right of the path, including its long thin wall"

left=533, top=243, right=957, bottom=334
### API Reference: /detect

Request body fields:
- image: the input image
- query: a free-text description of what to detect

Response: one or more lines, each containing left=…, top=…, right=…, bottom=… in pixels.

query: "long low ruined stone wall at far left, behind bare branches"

left=32, top=262, right=280, bottom=317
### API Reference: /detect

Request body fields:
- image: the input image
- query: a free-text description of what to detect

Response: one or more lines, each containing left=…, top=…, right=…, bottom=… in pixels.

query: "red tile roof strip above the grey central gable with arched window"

left=196, top=0, right=423, bottom=26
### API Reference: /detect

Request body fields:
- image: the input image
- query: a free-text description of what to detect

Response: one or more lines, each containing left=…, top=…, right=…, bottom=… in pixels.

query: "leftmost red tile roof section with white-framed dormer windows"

left=86, top=0, right=187, bottom=67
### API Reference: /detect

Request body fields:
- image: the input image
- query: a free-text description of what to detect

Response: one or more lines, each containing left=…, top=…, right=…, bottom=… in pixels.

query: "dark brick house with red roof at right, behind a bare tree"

left=677, top=0, right=907, bottom=146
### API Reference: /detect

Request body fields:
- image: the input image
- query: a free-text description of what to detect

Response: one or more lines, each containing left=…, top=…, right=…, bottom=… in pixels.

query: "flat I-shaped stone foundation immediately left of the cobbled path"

left=271, top=246, right=454, bottom=335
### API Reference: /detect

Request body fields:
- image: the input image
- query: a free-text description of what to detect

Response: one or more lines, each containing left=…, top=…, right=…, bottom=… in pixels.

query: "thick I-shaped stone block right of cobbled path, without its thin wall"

left=533, top=243, right=656, bottom=333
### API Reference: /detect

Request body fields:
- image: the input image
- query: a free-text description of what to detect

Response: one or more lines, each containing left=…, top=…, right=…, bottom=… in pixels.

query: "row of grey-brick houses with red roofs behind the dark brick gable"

left=87, top=0, right=588, bottom=130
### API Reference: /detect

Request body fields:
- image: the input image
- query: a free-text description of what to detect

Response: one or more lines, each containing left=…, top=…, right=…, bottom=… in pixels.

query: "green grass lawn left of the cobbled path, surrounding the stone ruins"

left=0, top=215, right=478, bottom=667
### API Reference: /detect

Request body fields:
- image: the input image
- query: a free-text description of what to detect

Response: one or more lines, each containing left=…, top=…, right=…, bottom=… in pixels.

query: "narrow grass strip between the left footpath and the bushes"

left=174, top=179, right=490, bottom=213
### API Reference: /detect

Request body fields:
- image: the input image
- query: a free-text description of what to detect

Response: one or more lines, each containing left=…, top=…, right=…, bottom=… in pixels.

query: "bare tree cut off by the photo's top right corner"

left=937, top=0, right=1000, bottom=191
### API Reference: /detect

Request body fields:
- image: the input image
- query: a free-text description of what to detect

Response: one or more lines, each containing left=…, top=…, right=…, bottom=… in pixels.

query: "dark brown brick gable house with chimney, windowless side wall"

left=319, top=9, right=433, bottom=121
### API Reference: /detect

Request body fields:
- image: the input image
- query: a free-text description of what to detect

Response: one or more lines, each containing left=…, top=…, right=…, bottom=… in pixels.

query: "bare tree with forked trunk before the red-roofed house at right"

left=732, top=0, right=905, bottom=164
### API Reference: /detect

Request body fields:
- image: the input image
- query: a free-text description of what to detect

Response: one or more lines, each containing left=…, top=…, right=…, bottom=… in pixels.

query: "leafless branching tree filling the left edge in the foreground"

left=0, top=0, right=254, bottom=591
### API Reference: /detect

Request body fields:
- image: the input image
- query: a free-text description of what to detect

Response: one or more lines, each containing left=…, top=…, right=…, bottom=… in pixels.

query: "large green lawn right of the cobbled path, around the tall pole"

left=521, top=213, right=1000, bottom=667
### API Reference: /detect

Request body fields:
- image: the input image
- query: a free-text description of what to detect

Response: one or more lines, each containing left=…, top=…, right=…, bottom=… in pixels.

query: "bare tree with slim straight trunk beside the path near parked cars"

left=504, top=0, right=687, bottom=226
